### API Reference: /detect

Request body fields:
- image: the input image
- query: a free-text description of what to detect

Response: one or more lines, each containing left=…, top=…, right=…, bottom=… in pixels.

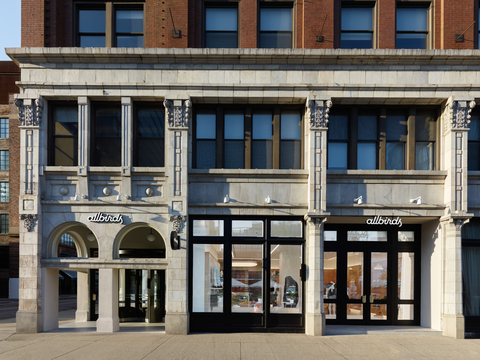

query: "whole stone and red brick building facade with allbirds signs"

left=8, top=0, right=480, bottom=338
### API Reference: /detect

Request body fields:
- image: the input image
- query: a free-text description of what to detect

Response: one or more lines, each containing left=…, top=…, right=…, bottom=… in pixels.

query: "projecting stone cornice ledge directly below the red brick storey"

left=6, top=47, right=480, bottom=66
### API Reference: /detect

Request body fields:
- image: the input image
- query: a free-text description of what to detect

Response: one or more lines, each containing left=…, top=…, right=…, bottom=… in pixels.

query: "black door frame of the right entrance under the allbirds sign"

left=324, top=224, right=421, bottom=325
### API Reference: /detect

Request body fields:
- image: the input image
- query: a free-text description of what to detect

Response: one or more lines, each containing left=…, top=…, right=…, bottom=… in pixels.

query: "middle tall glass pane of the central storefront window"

left=231, top=245, right=264, bottom=313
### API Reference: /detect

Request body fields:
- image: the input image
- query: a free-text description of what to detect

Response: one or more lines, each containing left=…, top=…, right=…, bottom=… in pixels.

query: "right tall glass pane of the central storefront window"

left=269, top=245, right=302, bottom=314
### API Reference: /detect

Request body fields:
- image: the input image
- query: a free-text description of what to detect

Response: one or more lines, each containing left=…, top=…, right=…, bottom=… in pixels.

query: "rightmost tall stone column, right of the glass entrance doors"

left=440, top=98, right=475, bottom=339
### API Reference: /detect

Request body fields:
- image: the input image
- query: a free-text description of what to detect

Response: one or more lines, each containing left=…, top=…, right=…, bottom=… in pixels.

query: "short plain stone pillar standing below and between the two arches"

left=97, top=269, right=120, bottom=332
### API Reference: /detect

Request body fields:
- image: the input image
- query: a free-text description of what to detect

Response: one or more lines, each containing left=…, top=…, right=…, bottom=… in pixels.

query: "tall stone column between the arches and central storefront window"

left=164, top=99, right=192, bottom=334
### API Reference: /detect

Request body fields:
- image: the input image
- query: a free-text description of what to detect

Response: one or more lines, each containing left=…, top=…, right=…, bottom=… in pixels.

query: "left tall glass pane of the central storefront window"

left=192, top=244, right=224, bottom=312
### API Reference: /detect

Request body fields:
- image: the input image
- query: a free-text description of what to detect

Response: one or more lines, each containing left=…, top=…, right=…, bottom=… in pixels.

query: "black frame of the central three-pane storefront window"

left=188, top=216, right=305, bottom=333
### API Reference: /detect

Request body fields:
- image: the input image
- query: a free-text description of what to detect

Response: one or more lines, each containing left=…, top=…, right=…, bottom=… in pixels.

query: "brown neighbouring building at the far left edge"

left=0, top=61, right=20, bottom=299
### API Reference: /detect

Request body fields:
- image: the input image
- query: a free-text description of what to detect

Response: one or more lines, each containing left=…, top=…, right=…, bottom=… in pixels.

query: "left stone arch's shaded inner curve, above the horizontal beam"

left=43, top=221, right=98, bottom=258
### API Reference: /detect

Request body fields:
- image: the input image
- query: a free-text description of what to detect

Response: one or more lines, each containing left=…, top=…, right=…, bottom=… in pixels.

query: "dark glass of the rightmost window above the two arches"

left=134, top=108, right=165, bottom=167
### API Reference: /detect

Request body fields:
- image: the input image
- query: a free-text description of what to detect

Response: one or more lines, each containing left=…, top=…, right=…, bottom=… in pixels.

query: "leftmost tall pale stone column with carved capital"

left=15, top=98, right=43, bottom=333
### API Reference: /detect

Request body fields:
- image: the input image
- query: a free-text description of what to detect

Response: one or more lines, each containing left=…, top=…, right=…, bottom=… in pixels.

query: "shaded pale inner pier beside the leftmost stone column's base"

left=42, top=268, right=59, bottom=331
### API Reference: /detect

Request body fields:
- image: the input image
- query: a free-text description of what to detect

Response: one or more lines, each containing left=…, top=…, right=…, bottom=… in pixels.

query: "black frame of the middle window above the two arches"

left=90, top=102, right=123, bottom=167
